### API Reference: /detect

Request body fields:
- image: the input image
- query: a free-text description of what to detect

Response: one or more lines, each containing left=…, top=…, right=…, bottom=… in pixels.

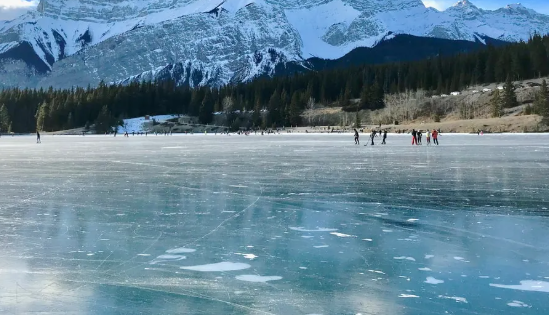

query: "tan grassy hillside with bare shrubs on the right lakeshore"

left=301, top=77, right=549, bottom=133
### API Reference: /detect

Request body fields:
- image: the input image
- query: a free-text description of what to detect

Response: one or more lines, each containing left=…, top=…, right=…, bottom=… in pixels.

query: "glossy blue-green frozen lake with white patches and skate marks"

left=0, top=134, right=549, bottom=315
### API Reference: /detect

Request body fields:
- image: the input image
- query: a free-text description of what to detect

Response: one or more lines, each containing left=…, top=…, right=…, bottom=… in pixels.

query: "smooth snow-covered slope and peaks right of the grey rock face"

left=286, top=0, right=549, bottom=59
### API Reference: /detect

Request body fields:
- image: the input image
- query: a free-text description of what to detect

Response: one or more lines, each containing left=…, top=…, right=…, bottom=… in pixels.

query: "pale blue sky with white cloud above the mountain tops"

left=0, top=0, right=549, bottom=20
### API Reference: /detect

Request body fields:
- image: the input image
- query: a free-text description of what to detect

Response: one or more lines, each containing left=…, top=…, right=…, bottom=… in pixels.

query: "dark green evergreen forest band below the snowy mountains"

left=0, top=35, right=549, bottom=132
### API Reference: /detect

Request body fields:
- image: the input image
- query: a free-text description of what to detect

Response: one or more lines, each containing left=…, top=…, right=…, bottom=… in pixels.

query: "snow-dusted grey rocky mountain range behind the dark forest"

left=0, top=0, right=549, bottom=87
